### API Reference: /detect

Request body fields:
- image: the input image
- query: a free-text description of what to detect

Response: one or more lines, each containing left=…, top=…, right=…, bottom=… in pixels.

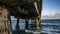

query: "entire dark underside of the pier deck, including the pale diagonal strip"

left=0, top=0, right=42, bottom=19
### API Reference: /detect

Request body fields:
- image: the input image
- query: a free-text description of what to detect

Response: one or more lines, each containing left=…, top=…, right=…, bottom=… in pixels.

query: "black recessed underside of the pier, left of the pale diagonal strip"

left=10, top=3, right=38, bottom=19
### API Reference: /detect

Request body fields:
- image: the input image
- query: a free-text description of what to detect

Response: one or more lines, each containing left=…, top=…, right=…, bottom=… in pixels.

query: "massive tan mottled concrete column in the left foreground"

left=0, top=5, right=12, bottom=34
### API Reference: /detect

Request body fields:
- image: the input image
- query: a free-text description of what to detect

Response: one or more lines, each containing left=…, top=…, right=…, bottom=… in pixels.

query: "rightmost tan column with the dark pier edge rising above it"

left=36, top=0, right=43, bottom=29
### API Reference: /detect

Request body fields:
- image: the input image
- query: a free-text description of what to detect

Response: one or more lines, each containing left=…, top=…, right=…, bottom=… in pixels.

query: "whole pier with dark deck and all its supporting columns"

left=0, top=0, right=42, bottom=34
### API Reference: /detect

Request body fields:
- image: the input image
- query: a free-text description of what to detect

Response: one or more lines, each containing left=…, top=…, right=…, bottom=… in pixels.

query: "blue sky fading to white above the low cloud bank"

left=42, top=0, right=60, bottom=16
